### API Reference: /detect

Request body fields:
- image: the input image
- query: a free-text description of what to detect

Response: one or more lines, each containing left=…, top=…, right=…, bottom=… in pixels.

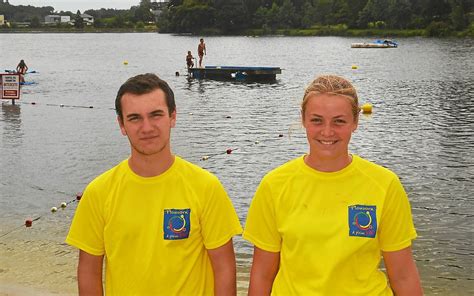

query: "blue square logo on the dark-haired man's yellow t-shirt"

left=163, top=209, right=191, bottom=240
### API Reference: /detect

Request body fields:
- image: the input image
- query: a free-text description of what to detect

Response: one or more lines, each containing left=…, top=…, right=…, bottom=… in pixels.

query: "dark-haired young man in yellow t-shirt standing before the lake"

left=66, top=74, right=242, bottom=295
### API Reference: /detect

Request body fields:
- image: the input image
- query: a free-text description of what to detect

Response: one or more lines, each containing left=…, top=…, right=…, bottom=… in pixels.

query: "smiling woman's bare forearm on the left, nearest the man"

left=249, top=247, right=280, bottom=296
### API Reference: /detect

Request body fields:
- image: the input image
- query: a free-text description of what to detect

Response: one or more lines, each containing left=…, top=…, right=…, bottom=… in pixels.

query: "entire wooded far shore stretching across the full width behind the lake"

left=0, top=0, right=474, bottom=36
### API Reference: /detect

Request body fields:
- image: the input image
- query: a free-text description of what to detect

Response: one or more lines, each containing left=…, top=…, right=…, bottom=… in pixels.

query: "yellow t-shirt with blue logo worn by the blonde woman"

left=243, top=155, right=416, bottom=296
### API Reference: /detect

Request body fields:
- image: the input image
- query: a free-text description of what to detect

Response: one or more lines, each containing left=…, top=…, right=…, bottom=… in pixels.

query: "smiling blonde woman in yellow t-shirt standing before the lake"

left=243, top=75, right=423, bottom=296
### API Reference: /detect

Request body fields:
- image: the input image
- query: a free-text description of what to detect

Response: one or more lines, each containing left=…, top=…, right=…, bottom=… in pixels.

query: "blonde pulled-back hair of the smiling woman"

left=301, top=75, right=360, bottom=120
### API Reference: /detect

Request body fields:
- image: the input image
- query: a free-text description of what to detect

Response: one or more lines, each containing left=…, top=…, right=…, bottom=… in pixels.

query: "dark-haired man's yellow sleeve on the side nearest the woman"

left=201, top=178, right=242, bottom=249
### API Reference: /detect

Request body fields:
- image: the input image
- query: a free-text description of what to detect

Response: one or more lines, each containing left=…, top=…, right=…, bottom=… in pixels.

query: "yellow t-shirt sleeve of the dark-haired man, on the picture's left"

left=66, top=183, right=105, bottom=256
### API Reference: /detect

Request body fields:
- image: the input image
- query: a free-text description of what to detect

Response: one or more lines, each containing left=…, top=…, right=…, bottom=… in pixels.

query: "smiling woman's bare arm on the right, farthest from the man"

left=382, top=247, right=423, bottom=296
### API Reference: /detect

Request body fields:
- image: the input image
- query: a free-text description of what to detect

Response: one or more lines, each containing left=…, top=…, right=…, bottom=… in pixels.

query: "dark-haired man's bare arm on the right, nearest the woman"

left=207, top=239, right=237, bottom=296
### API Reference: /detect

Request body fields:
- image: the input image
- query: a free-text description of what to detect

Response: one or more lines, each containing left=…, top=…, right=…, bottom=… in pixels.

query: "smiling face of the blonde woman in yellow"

left=302, top=94, right=358, bottom=161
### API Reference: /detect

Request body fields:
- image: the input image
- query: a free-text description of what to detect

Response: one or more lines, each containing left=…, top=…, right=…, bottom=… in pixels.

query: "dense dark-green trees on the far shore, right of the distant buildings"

left=158, top=0, right=474, bottom=34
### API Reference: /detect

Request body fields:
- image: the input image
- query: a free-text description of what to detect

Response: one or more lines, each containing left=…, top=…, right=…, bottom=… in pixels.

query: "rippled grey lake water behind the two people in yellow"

left=0, top=33, right=474, bottom=295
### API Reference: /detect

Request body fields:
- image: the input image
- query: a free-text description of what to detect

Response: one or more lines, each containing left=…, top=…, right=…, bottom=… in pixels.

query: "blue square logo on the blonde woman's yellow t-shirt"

left=349, top=205, right=377, bottom=238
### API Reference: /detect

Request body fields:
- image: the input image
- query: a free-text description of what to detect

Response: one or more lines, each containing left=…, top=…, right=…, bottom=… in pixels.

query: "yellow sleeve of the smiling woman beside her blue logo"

left=379, top=178, right=417, bottom=252
